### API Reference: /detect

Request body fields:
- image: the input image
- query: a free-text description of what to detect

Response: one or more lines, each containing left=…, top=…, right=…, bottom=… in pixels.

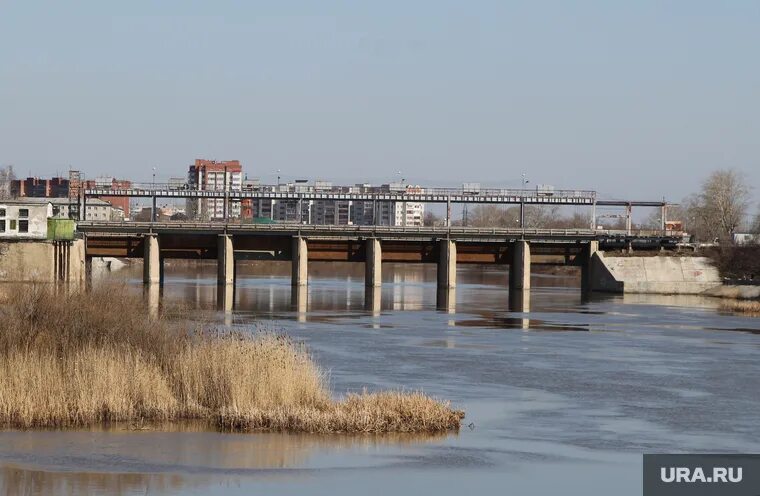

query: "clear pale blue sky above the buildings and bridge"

left=0, top=0, right=760, bottom=205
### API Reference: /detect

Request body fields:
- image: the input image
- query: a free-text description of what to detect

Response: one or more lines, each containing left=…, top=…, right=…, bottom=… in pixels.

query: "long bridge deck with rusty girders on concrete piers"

left=77, top=221, right=679, bottom=307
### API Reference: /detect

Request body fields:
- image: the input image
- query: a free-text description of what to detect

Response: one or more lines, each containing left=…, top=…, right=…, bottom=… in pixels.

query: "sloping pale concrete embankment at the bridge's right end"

left=590, top=252, right=721, bottom=294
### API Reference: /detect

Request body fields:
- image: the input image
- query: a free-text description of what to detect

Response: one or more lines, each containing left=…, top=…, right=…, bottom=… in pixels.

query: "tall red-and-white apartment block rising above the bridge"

left=186, top=159, right=243, bottom=220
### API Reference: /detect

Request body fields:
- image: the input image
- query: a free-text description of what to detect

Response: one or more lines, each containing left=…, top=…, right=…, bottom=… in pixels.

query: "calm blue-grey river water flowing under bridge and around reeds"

left=0, top=263, right=760, bottom=495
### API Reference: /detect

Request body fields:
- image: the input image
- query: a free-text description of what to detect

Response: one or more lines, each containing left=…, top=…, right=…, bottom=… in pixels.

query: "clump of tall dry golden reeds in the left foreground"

left=0, top=286, right=463, bottom=433
